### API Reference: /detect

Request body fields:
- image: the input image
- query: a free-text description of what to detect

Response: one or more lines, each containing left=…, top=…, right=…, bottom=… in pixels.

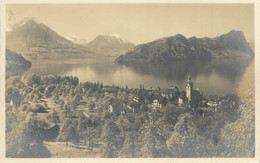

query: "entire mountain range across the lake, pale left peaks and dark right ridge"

left=6, top=18, right=254, bottom=63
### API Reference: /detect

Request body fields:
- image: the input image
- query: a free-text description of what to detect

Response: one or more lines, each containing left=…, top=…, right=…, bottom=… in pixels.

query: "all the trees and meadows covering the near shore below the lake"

left=6, top=74, right=255, bottom=158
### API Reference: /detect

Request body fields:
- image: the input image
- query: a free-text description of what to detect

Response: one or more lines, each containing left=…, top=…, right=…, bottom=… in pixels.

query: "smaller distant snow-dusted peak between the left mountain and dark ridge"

left=88, top=34, right=134, bottom=57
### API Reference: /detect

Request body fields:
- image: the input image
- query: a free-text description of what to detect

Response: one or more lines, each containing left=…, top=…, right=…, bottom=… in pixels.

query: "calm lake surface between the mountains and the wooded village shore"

left=27, top=58, right=254, bottom=95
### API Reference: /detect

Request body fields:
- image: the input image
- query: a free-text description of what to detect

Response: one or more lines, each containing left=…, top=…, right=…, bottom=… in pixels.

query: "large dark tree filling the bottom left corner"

left=6, top=117, right=50, bottom=158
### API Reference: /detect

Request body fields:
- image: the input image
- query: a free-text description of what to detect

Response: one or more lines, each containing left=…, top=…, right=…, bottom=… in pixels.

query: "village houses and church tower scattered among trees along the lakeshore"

left=7, top=76, right=221, bottom=118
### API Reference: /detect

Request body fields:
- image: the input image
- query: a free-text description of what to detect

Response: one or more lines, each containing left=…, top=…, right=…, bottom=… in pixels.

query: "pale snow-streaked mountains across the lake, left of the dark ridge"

left=6, top=18, right=134, bottom=58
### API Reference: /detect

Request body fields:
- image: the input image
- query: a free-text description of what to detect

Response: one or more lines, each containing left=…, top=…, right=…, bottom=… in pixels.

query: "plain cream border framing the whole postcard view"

left=0, top=0, right=260, bottom=163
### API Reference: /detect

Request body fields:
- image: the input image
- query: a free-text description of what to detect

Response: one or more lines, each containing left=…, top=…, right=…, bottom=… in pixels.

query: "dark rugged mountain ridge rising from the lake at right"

left=115, top=30, right=254, bottom=63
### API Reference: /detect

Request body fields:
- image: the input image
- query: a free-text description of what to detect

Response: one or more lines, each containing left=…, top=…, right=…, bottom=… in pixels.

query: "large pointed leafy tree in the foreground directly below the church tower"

left=166, top=113, right=214, bottom=157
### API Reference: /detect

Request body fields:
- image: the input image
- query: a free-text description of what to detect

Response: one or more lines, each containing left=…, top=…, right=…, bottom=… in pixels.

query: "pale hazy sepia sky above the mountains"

left=6, top=4, right=254, bottom=44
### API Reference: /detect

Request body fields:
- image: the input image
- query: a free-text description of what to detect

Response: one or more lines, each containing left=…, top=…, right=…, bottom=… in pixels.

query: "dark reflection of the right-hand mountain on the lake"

left=121, top=58, right=250, bottom=82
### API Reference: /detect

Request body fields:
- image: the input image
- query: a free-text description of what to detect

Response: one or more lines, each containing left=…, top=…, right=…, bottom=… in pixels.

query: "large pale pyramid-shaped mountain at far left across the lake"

left=6, top=18, right=91, bottom=58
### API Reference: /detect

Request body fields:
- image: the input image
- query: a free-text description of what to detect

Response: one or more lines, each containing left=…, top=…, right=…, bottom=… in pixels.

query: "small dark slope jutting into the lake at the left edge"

left=5, top=49, right=32, bottom=76
